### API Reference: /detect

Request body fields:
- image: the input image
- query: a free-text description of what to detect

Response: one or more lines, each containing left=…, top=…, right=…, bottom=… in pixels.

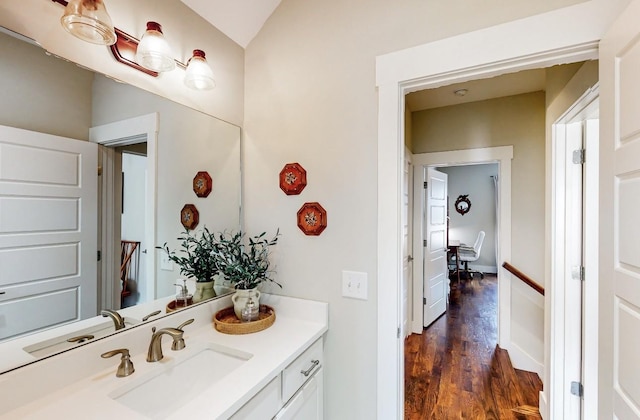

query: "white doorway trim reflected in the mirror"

left=89, top=112, right=159, bottom=307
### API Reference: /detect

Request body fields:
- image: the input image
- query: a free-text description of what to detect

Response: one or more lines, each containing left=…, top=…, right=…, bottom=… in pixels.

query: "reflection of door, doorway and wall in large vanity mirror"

left=0, top=27, right=241, bottom=372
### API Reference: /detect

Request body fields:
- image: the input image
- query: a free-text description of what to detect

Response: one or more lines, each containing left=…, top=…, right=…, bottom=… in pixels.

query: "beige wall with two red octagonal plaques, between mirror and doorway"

left=244, top=0, right=579, bottom=420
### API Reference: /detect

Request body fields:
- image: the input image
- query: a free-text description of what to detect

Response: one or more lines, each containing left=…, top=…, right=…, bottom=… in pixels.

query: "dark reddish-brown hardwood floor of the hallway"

left=405, top=275, right=542, bottom=420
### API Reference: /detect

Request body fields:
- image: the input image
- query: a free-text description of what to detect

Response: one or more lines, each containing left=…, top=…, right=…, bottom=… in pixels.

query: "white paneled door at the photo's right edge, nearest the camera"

left=599, top=0, right=640, bottom=419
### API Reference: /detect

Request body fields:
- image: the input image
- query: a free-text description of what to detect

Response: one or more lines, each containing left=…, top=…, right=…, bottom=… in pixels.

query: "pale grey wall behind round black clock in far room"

left=438, top=164, right=498, bottom=273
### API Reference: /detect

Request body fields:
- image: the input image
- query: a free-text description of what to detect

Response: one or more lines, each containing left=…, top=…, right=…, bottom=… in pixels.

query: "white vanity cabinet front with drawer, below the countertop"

left=230, top=338, right=324, bottom=420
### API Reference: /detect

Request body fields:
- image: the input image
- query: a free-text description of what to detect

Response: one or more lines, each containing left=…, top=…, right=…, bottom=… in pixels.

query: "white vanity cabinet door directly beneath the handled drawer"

left=274, top=367, right=323, bottom=420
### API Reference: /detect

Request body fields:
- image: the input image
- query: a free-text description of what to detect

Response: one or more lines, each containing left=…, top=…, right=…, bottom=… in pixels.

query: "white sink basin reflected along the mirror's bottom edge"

left=23, top=318, right=140, bottom=358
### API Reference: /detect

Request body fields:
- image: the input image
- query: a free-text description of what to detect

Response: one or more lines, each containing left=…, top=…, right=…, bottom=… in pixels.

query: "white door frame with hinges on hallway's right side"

left=546, top=85, right=599, bottom=418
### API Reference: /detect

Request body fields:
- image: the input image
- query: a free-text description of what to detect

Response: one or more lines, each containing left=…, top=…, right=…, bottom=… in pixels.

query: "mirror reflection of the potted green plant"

left=156, top=227, right=219, bottom=302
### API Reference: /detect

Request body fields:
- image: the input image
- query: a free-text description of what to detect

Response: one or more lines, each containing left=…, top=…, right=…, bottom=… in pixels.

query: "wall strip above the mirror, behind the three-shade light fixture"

left=0, top=0, right=244, bottom=124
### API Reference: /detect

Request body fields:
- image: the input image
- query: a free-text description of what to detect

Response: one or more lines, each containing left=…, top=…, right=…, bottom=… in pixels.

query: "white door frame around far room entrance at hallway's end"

left=412, top=146, right=513, bottom=334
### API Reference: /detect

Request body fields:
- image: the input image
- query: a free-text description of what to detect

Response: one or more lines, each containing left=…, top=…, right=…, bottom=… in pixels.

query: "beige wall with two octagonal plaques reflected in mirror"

left=93, top=76, right=241, bottom=296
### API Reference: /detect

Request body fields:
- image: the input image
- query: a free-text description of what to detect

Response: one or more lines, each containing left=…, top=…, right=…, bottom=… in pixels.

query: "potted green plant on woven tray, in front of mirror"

left=213, top=229, right=282, bottom=318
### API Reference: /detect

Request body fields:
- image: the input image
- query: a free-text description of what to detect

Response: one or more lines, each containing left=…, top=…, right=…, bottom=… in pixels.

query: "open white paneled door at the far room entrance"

left=423, top=168, right=449, bottom=327
